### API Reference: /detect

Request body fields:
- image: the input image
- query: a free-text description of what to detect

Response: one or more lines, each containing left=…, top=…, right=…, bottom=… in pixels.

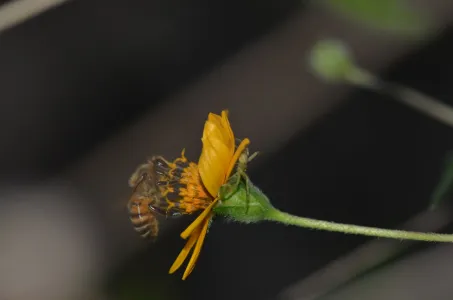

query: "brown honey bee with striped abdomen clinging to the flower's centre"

left=127, top=156, right=181, bottom=240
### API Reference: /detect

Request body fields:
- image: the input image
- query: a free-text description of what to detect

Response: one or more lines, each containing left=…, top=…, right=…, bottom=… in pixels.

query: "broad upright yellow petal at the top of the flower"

left=198, top=111, right=235, bottom=198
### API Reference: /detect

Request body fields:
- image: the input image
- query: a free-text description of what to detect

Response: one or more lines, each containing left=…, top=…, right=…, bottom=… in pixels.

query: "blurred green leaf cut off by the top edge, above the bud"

left=323, top=0, right=431, bottom=36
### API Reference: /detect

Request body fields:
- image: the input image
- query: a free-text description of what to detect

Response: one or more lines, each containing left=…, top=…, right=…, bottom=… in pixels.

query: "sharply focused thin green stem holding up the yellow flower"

left=266, top=209, right=453, bottom=242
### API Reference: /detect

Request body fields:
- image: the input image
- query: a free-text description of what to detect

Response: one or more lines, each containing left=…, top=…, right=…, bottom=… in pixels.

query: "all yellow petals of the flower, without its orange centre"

left=169, top=110, right=250, bottom=280
